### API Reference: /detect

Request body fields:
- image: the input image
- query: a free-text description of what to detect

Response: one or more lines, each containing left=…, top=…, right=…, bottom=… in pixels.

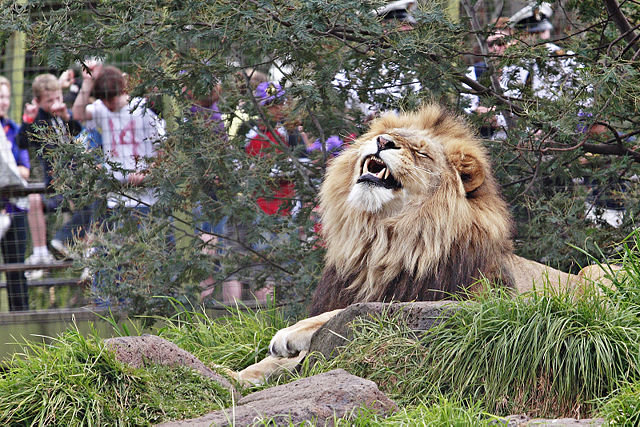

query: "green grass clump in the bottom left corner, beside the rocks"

left=0, top=329, right=231, bottom=426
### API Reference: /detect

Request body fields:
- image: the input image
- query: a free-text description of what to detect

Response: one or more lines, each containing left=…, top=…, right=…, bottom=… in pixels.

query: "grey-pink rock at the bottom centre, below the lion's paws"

left=156, top=369, right=397, bottom=427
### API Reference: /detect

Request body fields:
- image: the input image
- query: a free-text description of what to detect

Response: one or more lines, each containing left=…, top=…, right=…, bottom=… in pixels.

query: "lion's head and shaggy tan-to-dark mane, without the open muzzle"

left=310, top=105, right=513, bottom=315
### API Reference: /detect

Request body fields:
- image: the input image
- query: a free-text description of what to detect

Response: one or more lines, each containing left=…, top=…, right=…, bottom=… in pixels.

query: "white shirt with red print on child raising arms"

left=86, top=98, right=165, bottom=207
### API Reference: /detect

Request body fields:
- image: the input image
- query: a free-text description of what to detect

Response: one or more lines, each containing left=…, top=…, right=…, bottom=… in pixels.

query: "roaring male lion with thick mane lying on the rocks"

left=236, top=105, right=616, bottom=383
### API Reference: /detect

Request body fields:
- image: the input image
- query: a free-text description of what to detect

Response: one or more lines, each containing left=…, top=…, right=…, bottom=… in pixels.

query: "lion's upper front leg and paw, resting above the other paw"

left=269, top=308, right=343, bottom=357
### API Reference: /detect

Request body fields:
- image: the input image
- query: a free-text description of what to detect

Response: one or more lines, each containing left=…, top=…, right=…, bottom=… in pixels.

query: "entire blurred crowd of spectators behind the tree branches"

left=0, top=0, right=608, bottom=311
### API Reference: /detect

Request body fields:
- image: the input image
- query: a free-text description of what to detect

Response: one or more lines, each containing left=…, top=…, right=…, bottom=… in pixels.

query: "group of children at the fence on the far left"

left=0, top=62, right=165, bottom=311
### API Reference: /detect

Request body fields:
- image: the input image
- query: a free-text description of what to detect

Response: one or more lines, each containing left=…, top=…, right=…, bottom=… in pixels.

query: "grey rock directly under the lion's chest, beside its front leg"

left=310, top=301, right=458, bottom=359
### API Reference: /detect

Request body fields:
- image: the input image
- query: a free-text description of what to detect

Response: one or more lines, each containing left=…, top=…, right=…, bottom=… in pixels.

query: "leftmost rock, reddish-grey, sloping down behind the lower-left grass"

left=104, top=335, right=240, bottom=398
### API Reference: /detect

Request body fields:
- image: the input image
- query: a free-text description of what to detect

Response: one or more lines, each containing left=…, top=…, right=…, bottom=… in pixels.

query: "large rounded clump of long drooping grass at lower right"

left=425, top=290, right=640, bottom=415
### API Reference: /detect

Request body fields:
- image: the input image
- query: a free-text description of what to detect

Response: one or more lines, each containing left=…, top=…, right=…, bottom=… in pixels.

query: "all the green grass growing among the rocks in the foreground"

left=6, top=235, right=640, bottom=426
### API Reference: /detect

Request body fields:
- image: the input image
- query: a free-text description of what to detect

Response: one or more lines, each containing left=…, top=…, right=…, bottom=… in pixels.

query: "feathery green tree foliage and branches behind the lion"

left=0, top=0, right=640, bottom=315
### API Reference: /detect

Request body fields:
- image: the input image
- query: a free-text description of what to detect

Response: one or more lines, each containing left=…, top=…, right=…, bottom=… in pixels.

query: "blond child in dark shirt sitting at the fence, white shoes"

left=18, top=74, right=82, bottom=280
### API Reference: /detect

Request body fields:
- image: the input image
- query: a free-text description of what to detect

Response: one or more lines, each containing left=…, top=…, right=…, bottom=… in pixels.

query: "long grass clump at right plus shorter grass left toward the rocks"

left=306, top=288, right=640, bottom=417
